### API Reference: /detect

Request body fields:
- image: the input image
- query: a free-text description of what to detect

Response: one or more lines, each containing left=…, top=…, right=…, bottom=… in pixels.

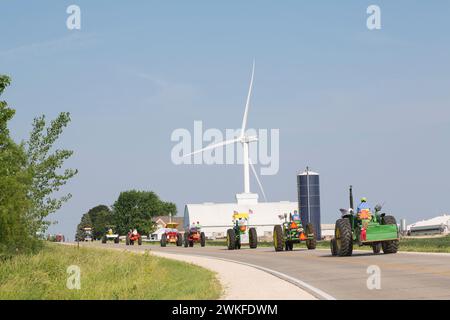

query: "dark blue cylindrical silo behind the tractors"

left=297, top=167, right=321, bottom=240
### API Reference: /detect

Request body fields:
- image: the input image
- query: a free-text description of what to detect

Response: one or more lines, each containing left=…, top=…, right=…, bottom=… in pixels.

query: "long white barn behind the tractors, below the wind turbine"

left=184, top=201, right=298, bottom=239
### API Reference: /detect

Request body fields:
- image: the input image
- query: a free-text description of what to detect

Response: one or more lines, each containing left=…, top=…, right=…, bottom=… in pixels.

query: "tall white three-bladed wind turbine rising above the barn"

left=184, top=60, right=267, bottom=201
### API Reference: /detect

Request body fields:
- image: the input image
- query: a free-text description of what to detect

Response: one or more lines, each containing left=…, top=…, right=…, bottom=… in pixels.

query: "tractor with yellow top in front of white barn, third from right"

left=227, top=211, right=258, bottom=250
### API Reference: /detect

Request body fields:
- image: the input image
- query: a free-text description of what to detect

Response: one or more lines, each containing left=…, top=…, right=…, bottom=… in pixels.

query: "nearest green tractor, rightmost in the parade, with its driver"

left=330, top=186, right=399, bottom=257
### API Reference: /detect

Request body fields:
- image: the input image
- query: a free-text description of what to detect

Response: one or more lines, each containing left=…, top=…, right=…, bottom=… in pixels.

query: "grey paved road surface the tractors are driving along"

left=86, top=244, right=450, bottom=299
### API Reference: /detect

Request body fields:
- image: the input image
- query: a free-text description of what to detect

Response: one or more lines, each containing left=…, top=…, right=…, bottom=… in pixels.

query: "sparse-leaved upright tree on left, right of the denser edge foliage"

left=26, top=112, right=78, bottom=232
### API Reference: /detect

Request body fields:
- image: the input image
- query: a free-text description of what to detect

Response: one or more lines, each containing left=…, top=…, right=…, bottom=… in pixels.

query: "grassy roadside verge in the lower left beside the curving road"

left=0, top=244, right=222, bottom=300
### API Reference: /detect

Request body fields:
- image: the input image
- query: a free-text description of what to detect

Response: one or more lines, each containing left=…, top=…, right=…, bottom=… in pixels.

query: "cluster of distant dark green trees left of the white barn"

left=75, top=190, right=177, bottom=240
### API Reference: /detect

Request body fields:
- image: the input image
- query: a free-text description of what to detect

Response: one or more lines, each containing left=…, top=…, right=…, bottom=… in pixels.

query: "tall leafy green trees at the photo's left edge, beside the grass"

left=0, top=75, right=77, bottom=259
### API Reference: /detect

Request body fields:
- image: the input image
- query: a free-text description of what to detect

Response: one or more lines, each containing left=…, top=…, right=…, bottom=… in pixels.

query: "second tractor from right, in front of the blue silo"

left=273, top=213, right=316, bottom=251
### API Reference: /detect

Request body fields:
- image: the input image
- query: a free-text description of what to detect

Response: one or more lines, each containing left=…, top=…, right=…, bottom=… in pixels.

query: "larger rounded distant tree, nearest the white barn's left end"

left=113, top=190, right=177, bottom=234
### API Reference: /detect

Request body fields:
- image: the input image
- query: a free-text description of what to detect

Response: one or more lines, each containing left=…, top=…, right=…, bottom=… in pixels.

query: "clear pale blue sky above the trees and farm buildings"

left=0, top=0, right=450, bottom=238
